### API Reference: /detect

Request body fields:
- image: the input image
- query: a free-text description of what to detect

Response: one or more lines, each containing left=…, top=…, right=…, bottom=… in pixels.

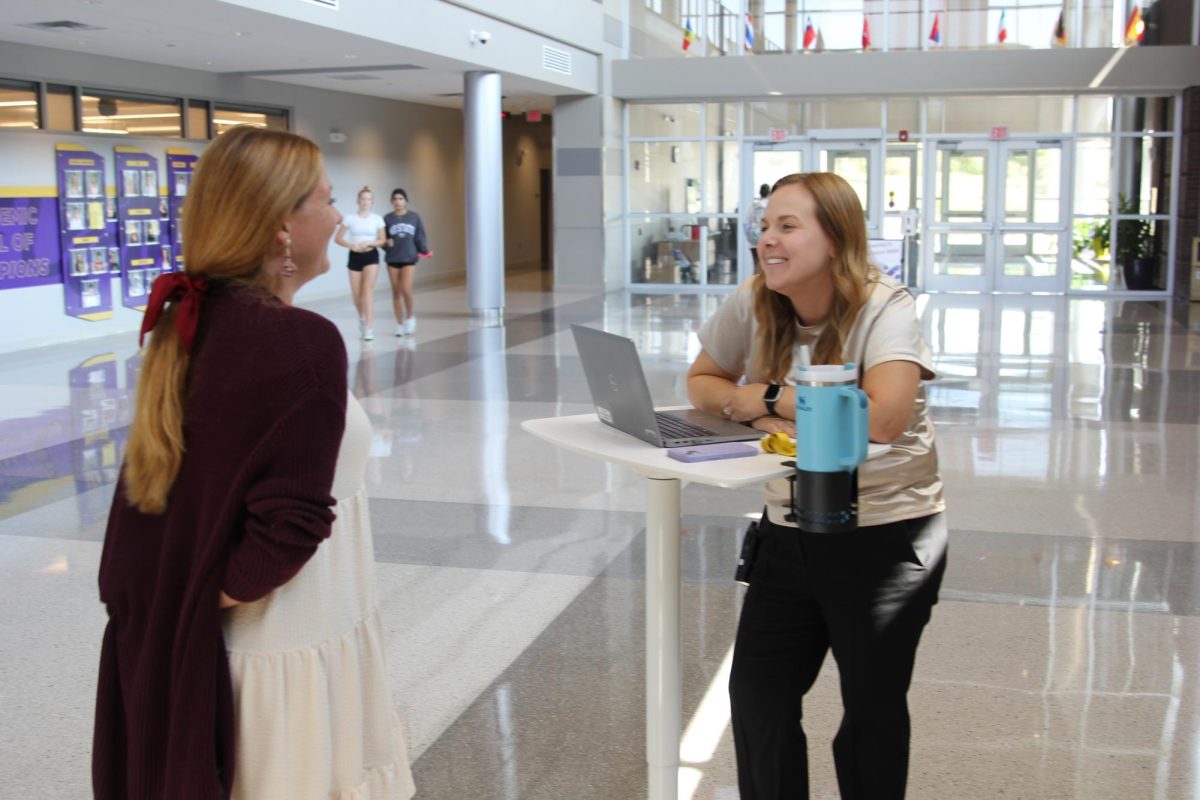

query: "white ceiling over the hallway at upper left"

left=0, top=0, right=554, bottom=113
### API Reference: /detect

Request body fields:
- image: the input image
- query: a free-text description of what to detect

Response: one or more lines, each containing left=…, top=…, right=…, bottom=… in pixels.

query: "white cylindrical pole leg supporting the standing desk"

left=646, top=477, right=683, bottom=800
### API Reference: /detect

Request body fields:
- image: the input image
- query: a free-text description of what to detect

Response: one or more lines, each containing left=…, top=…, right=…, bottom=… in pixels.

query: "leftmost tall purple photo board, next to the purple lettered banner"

left=55, top=144, right=113, bottom=321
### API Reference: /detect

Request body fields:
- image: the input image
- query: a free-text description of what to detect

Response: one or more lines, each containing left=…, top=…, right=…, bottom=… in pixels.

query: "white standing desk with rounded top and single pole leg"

left=521, top=414, right=793, bottom=800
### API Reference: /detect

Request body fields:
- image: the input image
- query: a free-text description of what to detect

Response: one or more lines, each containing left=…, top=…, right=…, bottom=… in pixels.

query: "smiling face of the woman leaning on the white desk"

left=758, top=184, right=835, bottom=297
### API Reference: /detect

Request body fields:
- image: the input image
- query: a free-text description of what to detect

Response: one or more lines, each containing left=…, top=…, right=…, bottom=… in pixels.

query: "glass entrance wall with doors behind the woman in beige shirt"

left=625, top=95, right=1183, bottom=293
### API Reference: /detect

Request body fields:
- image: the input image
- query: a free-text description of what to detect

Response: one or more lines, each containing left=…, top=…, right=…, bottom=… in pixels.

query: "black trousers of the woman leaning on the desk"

left=730, top=513, right=947, bottom=800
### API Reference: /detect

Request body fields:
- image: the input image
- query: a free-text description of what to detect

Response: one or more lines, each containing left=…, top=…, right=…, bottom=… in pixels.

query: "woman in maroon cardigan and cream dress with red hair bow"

left=92, top=126, right=413, bottom=800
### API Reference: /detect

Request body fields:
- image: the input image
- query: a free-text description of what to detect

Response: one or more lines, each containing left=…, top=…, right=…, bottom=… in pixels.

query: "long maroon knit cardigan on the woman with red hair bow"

left=92, top=285, right=347, bottom=800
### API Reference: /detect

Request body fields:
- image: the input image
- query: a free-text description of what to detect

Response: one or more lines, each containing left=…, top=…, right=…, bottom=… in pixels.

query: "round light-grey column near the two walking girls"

left=463, top=72, right=504, bottom=325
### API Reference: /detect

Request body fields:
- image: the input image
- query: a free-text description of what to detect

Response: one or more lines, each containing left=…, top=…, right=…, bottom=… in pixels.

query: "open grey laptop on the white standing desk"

left=571, top=324, right=763, bottom=447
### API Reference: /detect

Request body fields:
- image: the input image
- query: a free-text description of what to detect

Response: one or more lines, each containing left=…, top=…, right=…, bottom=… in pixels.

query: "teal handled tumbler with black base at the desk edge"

left=792, top=363, right=868, bottom=534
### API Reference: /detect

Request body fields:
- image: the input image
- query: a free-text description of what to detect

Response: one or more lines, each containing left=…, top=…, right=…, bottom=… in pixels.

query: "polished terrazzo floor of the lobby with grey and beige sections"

left=0, top=273, right=1200, bottom=800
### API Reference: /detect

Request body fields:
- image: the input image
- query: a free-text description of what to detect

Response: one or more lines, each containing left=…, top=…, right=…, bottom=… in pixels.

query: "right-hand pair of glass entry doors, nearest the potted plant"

left=923, top=140, right=1069, bottom=293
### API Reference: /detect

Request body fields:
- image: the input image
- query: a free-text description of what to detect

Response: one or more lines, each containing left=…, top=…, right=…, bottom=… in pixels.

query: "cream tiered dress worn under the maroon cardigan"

left=224, top=396, right=415, bottom=800
